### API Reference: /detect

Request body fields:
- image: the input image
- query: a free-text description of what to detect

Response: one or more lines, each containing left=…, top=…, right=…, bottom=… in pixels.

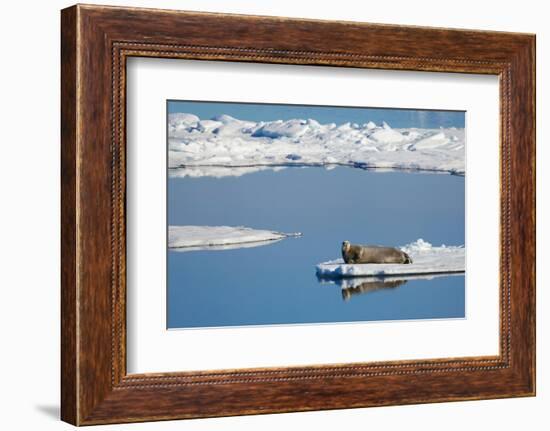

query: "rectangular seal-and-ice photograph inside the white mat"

left=166, top=100, right=467, bottom=329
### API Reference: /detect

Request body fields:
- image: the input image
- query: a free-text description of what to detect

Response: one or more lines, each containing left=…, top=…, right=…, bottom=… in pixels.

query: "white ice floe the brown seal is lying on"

left=317, top=239, right=466, bottom=278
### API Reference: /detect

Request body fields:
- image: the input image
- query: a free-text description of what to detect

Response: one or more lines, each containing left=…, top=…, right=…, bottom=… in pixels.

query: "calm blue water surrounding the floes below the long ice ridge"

left=167, top=167, right=465, bottom=328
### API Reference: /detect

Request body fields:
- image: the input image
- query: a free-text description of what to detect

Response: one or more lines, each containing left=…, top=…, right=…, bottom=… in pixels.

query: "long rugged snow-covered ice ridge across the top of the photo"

left=168, top=113, right=465, bottom=177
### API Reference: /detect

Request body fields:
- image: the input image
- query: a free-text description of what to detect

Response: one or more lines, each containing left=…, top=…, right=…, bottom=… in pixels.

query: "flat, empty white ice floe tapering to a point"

left=168, top=226, right=302, bottom=251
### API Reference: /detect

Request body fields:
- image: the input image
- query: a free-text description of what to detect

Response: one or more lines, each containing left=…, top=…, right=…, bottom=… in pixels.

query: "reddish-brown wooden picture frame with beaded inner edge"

left=61, top=5, right=535, bottom=425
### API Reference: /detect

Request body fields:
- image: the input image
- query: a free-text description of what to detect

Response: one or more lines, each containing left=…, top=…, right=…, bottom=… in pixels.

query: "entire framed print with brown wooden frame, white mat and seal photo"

left=61, top=5, right=535, bottom=425
